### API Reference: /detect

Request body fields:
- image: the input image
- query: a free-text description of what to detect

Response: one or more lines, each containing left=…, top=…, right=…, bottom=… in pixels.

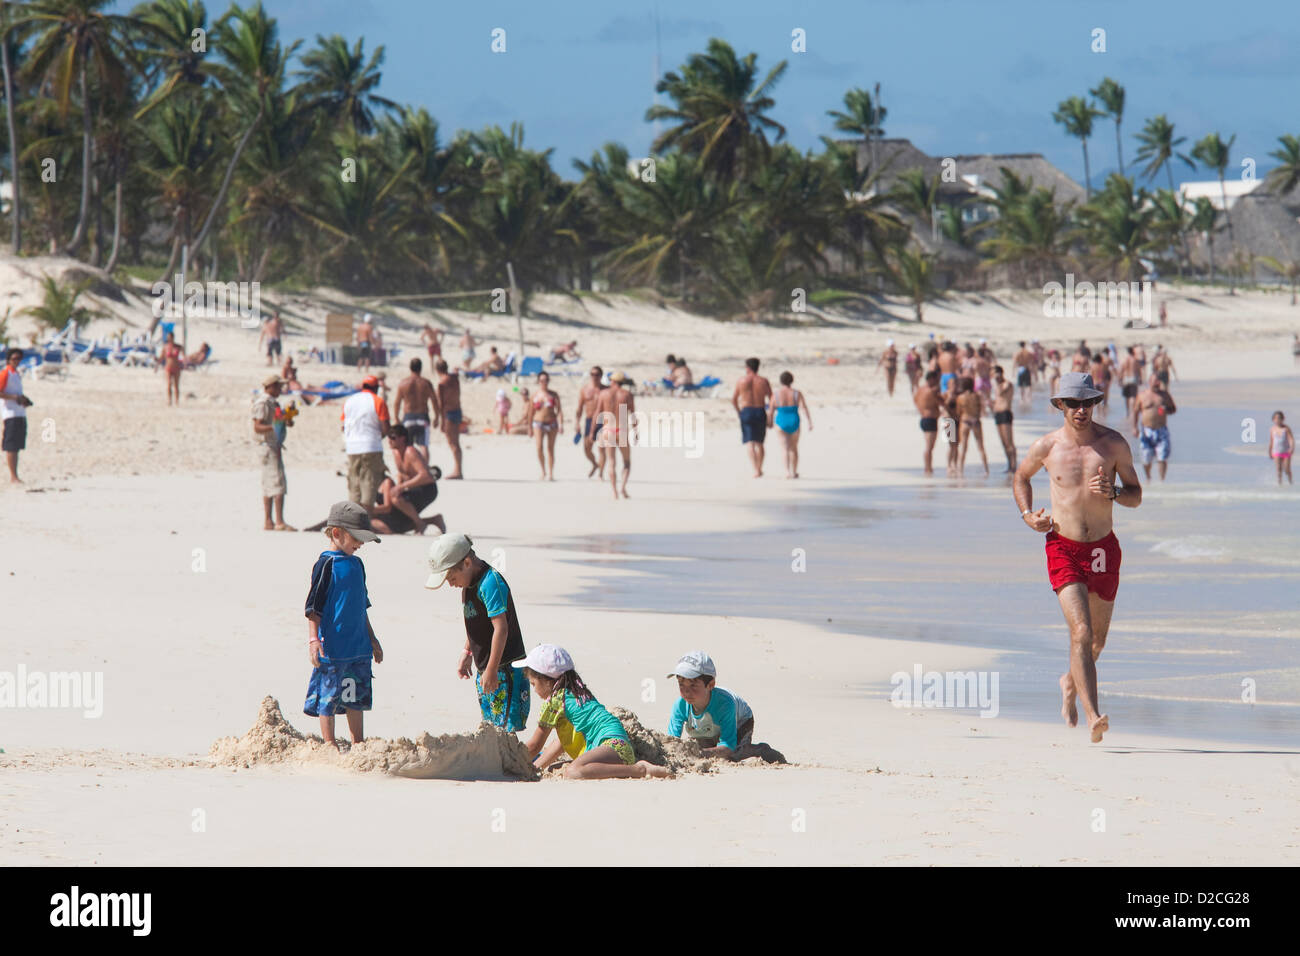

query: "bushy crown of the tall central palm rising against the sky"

left=646, top=38, right=788, bottom=179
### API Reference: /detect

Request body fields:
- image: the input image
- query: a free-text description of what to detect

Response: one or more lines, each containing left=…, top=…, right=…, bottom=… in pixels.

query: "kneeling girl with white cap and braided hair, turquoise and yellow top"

left=521, top=644, right=668, bottom=780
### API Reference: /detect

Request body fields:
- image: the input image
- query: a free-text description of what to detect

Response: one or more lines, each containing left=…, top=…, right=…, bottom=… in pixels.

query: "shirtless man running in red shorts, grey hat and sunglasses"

left=1013, top=372, right=1141, bottom=744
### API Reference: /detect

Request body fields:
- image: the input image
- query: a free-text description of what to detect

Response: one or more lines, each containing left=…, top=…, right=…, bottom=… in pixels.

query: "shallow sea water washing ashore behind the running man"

left=556, top=377, right=1300, bottom=748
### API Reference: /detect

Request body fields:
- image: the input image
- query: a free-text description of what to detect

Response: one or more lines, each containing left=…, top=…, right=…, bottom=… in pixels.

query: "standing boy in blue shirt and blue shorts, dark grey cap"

left=303, top=501, right=384, bottom=745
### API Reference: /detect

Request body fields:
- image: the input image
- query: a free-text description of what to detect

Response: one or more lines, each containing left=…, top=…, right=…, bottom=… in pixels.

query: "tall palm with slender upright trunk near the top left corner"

left=13, top=0, right=134, bottom=255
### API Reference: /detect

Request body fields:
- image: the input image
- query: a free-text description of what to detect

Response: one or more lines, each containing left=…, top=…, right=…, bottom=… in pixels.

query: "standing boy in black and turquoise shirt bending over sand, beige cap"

left=424, top=535, right=529, bottom=732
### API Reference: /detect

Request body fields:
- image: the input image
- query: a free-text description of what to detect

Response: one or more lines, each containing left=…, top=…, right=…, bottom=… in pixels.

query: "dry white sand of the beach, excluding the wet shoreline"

left=0, top=261, right=1300, bottom=865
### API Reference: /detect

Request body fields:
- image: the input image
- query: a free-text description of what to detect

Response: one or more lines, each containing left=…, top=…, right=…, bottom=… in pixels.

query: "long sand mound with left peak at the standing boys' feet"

left=208, top=697, right=538, bottom=780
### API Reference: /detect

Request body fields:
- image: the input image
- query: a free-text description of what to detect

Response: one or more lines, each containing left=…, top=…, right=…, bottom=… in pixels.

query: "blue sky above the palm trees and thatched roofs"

left=120, top=0, right=1300, bottom=186
